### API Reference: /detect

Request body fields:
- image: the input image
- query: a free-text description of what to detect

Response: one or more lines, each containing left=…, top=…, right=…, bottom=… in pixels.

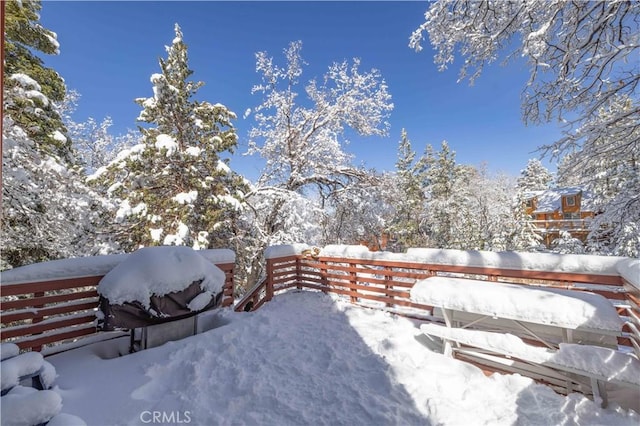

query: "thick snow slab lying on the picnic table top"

left=411, top=277, right=623, bottom=332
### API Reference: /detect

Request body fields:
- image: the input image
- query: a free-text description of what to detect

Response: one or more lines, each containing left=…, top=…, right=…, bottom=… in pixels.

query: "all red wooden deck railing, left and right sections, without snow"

left=0, top=245, right=640, bottom=353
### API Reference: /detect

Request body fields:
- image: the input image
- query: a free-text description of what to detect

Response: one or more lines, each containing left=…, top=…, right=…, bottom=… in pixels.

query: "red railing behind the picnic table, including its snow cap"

left=244, top=244, right=640, bottom=352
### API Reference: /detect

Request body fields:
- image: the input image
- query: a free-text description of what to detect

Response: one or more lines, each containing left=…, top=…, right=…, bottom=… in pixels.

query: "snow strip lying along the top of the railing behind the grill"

left=0, top=249, right=236, bottom=285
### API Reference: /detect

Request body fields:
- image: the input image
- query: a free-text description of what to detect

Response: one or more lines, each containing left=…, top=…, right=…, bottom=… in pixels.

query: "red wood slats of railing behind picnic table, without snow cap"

left=235, top=251, right=640, bottom=353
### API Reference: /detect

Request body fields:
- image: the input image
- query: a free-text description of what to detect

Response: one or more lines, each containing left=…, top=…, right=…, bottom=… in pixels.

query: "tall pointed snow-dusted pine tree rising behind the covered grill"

left=91, top=24, right=247, bottom=251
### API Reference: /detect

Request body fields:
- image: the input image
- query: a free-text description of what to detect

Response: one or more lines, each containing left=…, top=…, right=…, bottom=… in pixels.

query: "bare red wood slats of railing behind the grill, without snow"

left=0, top=263, right=235, bottom=351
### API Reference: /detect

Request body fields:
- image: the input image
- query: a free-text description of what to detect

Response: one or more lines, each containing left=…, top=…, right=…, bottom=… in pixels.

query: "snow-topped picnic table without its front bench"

left=411, top=277, right=624, bottom=349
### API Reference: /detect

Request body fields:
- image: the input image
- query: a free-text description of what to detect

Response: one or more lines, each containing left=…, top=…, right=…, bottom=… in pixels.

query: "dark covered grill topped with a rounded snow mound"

left=98, top=247, right=225, bottom=351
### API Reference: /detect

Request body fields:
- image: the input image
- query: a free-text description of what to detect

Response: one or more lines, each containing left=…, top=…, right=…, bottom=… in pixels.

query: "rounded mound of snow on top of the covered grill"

left=98, top=246, right=226, bottom=308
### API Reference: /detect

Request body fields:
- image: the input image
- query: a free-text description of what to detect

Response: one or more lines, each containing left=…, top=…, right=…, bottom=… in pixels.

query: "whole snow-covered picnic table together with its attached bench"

left=411, top=277, right=640, bottom=406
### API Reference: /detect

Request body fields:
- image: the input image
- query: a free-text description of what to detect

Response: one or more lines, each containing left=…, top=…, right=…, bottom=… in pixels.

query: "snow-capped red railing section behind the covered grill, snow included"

left=0, top=249, right=235, bottom=351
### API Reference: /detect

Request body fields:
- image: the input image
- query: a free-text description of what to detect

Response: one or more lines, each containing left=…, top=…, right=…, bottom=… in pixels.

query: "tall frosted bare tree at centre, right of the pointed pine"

left=238, top=41, right=393, bottom=281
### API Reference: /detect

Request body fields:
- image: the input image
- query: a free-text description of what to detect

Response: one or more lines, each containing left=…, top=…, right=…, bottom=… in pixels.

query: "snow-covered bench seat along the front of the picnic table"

left=420, top=324, right=640, bottom=408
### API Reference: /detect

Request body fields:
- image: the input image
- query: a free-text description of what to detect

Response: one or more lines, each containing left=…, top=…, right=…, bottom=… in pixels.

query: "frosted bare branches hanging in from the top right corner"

left=409, top=0, right=640, bottom=157
